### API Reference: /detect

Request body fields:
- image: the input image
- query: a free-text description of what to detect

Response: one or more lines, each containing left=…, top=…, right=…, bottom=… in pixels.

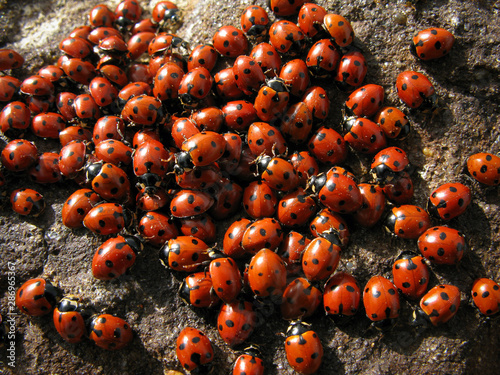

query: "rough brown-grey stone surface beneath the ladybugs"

left=0, top=0, right=500, bottom=374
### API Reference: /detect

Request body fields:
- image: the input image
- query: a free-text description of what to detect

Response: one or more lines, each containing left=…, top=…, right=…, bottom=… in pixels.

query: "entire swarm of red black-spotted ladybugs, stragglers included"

left=0, top=0, right=500, bottom=374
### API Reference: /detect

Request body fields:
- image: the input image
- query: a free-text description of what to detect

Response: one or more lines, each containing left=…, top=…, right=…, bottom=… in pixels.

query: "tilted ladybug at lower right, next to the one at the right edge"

left=420, top=285, right=460, bottom=326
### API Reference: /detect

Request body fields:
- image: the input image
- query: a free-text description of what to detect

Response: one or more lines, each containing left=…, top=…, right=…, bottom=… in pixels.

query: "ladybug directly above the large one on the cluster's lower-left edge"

left=83, top=203, right=131, bottom=236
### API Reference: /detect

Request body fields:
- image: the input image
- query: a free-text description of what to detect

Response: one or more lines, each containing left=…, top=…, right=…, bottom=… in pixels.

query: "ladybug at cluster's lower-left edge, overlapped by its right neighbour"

left=62, top=189, right=101, bottom=228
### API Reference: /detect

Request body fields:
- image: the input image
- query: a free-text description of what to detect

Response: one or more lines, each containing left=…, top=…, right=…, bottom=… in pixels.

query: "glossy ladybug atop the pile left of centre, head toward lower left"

left=181, top=131, right=227, bottom=167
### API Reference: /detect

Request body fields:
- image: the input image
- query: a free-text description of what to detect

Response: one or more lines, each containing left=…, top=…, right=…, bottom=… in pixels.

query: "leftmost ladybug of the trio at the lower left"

left=16, top=278, right=58, bottom=316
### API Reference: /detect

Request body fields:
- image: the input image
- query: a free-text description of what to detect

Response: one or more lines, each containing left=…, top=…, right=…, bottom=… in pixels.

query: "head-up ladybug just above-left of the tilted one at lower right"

left=392, top=251, right=430, bottom=300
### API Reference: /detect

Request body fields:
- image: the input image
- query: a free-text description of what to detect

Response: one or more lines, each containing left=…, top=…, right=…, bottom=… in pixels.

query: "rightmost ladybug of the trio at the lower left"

left=89, top=314, right=134, bottom=350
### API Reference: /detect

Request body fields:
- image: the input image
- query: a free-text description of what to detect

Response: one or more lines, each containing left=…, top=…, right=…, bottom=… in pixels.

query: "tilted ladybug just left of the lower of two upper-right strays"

left=345, top=84, right=385, bottom=117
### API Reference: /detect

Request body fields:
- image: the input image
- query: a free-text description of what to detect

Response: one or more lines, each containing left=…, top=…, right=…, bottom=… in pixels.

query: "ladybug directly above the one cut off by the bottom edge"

left=217, top=301, right=257, bottom=347
